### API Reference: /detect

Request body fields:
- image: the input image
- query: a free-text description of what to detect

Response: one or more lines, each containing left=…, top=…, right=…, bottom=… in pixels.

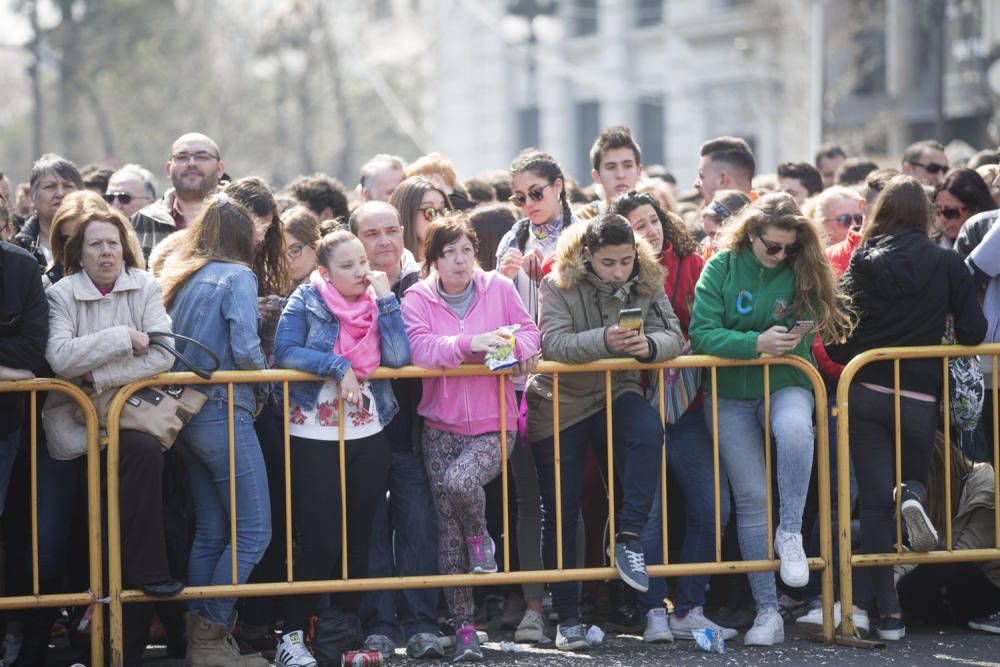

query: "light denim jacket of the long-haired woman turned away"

left=170, top=262, right=267, bottom=413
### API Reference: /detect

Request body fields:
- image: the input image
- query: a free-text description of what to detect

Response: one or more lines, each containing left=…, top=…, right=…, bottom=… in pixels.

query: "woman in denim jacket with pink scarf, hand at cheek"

left=275, top=230, right=410, bottom=665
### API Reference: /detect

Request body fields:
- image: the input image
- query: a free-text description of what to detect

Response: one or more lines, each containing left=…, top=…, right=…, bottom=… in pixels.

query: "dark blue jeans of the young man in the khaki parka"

left=531, top=392, right=663, bottom=621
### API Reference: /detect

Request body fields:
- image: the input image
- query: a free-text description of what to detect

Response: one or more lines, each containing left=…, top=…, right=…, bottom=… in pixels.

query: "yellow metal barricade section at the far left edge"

left=0, top=378, right=105, bottom=665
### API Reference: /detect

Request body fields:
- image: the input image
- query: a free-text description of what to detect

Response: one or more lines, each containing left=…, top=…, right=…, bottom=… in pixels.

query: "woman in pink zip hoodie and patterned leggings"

left=403, top=215, right=540, bottom=661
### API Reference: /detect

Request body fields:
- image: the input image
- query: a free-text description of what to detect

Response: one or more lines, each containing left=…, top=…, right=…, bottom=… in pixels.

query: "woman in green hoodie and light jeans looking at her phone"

left=689, top=193, right=850, bottom=646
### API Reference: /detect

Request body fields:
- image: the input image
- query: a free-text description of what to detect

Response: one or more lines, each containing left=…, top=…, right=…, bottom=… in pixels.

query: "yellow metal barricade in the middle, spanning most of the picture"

left=108, top=355, right=833, bottom=667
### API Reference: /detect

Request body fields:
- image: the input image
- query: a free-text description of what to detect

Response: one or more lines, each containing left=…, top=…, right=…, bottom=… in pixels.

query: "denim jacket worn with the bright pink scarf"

left=274, top=285, right=410, bottom=426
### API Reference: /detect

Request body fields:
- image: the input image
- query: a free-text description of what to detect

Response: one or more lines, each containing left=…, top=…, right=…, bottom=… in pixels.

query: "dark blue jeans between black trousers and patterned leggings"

left=360, top=451, right=440, bottom=640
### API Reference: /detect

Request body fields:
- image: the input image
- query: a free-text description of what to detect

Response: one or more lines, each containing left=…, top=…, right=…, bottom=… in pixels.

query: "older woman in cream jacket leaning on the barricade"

left=39, top=197, right=184, bottom=662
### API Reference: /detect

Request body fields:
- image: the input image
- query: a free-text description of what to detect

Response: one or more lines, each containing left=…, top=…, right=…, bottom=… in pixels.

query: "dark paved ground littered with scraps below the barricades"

left=117, top=624, right=1000, bottom=667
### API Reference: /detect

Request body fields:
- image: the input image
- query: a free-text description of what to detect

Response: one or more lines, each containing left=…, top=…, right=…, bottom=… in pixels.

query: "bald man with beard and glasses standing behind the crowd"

left=132, top=132, right=224, bottom=259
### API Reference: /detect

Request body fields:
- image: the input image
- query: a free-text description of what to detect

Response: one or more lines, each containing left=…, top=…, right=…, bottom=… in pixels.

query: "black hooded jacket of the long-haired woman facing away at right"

left=826, top=231, right=986, bottom=396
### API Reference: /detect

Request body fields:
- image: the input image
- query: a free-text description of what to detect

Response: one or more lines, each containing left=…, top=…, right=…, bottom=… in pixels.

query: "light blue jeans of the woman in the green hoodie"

left=705, top=387, right=815, bottom=611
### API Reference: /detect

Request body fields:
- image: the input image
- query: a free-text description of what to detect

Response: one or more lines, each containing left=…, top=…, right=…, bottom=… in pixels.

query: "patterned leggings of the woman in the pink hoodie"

left=423, top=426, right=517, bottom=627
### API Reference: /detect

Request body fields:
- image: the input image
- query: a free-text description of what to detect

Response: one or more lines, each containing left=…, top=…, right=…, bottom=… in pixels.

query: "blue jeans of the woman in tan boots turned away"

left=177, top=401, right=271, bottom=626
